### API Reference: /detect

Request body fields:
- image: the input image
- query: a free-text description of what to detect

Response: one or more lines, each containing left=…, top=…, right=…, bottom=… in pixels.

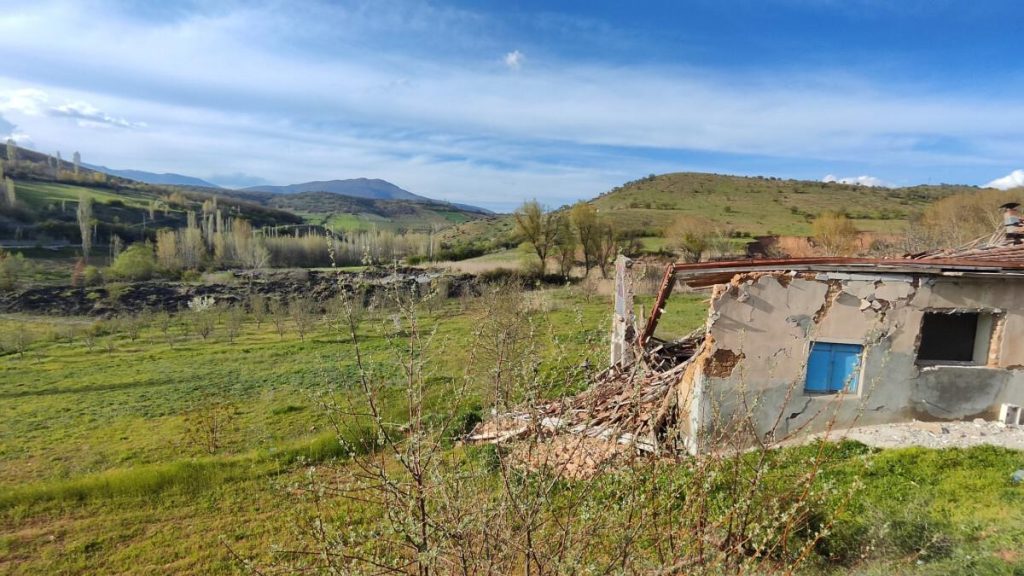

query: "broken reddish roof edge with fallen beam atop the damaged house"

left=638, top=256, right=1024, bottom=347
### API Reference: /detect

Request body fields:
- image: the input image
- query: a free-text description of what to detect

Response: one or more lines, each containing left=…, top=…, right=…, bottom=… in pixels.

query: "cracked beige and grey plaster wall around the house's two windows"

left=680, top=273, right=1024, bottom=449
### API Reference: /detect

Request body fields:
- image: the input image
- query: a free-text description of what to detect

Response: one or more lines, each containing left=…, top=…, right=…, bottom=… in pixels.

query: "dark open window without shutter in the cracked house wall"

left=918, top=311, right=992, bottom=364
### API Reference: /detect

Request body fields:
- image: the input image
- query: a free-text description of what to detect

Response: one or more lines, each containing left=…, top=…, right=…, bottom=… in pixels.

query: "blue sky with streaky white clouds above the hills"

left=0, top=0, right=1024, bottom=210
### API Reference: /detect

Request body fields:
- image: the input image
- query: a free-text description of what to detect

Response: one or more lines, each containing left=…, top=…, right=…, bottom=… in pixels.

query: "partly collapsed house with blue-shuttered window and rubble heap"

left=473, top=217, right=1024, bottom=459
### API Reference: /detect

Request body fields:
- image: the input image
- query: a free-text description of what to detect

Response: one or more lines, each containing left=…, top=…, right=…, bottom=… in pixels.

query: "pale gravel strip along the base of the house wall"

left=829, top=418, right=1024, bottom=450
